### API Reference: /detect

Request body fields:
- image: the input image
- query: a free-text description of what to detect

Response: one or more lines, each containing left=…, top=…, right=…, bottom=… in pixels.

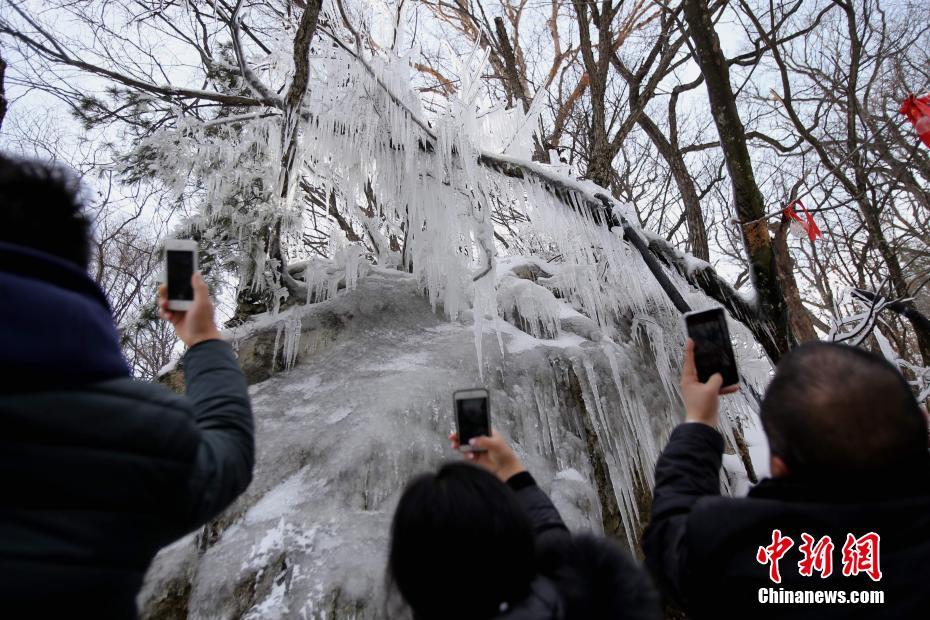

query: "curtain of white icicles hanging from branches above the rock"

left=127, top=1, right=762, bottom=548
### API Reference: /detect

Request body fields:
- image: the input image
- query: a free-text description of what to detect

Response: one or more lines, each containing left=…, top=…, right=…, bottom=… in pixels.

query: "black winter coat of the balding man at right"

left=643, top=423, right=930, bottom=619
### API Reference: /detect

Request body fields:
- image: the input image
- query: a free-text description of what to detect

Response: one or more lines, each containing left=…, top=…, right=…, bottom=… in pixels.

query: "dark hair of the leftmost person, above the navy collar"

left=0, top=155, right=90, bottom=269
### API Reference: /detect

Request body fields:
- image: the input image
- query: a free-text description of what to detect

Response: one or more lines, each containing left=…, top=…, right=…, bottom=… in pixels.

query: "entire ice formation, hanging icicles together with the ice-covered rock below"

left=129, top=3, right=769, bottom=618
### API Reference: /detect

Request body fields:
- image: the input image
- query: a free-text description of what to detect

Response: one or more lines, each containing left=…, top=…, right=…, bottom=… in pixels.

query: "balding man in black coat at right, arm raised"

left=643, top=341, right=930, bottom=619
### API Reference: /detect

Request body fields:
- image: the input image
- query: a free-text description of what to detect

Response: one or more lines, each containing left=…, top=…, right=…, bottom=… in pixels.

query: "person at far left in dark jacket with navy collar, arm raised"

left=0, top=157, right=254, bottom=618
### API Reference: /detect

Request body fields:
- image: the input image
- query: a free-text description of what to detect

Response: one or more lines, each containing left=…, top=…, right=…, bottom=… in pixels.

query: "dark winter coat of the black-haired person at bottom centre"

left=497, top=473, right=661, bottom=620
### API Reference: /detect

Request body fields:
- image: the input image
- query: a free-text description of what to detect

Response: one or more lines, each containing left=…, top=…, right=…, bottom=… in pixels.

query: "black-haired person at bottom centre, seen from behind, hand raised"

left=388, top=432, right=661, bottom=620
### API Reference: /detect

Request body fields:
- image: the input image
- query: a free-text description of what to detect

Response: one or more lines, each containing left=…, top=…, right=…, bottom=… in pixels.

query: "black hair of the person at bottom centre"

left=388, top=463, right=536, bottom=620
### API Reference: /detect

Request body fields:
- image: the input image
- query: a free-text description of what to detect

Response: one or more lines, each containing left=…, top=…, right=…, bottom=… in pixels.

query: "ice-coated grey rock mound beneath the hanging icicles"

left=140, top=269, right=761, bottom=619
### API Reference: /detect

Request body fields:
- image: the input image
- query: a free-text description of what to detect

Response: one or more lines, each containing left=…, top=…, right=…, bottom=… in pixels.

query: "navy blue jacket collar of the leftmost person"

left=0, top=243, right=129, bottom=392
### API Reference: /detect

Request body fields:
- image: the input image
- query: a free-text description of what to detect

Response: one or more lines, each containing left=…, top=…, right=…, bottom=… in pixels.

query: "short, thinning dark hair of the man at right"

left=761, top=342, right=928, bottom=476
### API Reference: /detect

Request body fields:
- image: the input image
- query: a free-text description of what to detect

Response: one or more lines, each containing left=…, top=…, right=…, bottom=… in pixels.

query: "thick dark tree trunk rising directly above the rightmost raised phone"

left=682, top=0, right=791, bottom=363
